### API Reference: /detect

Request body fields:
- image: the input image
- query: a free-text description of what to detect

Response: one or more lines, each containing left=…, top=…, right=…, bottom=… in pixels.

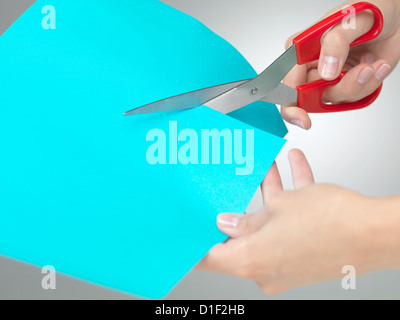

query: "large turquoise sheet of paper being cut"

left=0, top=0, right=286, bottom=298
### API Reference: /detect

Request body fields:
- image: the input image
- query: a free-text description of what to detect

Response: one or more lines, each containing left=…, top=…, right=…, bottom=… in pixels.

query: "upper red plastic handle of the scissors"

left=293, top=2, right=383, bottom=64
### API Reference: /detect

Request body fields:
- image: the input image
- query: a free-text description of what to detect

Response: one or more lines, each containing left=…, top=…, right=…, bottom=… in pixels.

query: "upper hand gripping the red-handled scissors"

left=282, top=0, right=400, bottom=129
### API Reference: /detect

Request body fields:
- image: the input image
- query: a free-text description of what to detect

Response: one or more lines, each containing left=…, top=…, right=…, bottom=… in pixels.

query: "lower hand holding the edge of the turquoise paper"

left=197, top=150, right=390, bottom=294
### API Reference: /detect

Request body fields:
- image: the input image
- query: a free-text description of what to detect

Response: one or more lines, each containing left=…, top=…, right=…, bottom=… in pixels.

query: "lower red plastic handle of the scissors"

left=296, top=71, right=382, bottom=113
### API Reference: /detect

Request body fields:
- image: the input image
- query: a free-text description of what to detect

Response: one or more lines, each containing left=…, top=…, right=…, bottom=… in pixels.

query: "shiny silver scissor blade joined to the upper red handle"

left=207, top=45, right=297, bottom=114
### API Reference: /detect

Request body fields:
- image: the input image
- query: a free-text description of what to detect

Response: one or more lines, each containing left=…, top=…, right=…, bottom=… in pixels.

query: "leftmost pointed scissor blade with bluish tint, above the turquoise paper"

left=124, top=80, right=249, bottom=116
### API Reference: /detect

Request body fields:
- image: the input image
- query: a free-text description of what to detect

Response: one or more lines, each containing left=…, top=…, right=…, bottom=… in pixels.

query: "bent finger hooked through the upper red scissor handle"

left=318, top=12, right=374, bottom=80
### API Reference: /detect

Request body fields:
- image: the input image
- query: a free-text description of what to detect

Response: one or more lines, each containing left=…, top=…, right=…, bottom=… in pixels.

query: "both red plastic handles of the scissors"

left=293, top=2, right=383, bottom=113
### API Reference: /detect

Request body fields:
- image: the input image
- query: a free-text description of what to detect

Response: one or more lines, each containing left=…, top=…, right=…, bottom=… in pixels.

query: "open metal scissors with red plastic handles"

left=124, top=2, right=383, bottom=116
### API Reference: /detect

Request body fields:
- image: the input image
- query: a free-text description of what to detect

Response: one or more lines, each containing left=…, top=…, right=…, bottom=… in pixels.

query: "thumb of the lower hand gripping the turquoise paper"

left=217, top=210, right=268, bottom=238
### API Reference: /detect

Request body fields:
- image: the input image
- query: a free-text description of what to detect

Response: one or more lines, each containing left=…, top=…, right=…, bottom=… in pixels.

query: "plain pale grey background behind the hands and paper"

left=0, top=0, right=400, bottom=300
